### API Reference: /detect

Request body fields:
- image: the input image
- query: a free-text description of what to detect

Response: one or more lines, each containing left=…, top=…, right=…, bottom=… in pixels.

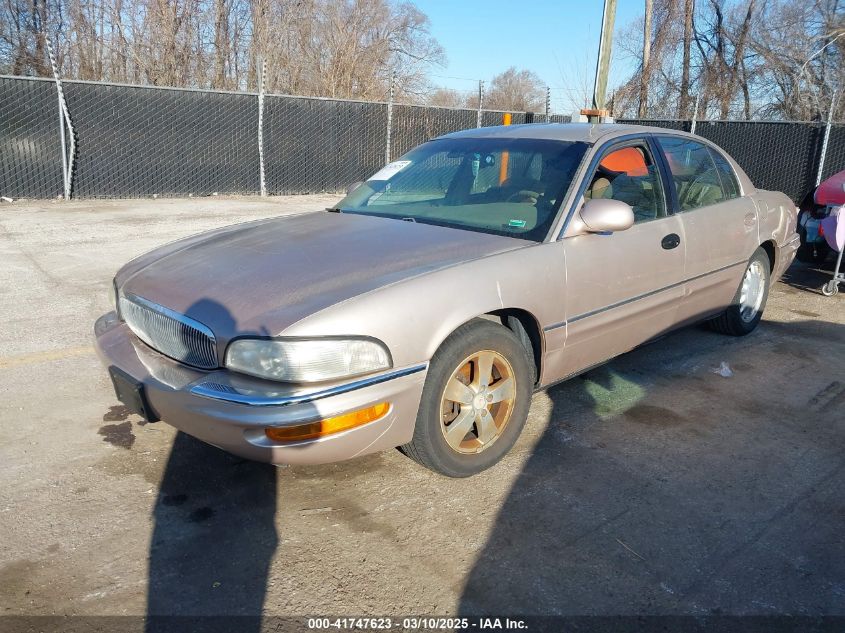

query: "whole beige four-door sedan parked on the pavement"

left=95, top=124, right=799, bottom=477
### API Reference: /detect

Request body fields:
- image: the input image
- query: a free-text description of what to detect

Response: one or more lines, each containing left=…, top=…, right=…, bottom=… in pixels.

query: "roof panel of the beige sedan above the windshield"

left=438, top=123, right=697, bottom=144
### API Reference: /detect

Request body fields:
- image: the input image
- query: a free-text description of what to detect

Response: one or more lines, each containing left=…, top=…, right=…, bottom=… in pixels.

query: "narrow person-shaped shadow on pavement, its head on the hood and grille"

left=145, top=299, right=279, bottom=633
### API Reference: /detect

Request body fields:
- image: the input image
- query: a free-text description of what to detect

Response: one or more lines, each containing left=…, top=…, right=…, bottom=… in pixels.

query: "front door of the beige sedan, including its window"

left=546, top=137, right=685, bottom=379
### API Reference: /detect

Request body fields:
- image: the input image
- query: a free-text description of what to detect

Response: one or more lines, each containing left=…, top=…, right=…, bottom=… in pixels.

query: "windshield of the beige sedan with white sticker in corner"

left=338, top=138, right=587, bottom=242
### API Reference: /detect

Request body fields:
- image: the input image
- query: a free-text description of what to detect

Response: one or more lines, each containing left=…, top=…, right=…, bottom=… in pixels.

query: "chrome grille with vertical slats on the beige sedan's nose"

left=120, top=295, right=218, bottom=369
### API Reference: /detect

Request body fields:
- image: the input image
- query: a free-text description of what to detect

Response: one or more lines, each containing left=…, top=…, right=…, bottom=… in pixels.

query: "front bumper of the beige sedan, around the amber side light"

left=94, top=312, right=427, bottom=464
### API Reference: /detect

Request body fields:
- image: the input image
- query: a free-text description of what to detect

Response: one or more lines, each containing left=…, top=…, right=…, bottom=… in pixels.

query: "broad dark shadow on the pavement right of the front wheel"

left=458, top=320, right=845, bottom=616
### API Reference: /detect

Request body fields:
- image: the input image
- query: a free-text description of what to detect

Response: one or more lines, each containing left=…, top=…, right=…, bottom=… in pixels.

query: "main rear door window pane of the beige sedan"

left=657, top=136, right=736, bottom=211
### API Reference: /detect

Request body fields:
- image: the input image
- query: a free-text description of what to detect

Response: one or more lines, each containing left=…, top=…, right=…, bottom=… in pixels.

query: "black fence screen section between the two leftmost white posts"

left=64, top=83, right=259, bottom=198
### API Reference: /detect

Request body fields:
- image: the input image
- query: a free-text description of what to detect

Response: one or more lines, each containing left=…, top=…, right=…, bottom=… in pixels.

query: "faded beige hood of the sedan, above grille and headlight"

left=117, top=212, right=528, bottom=345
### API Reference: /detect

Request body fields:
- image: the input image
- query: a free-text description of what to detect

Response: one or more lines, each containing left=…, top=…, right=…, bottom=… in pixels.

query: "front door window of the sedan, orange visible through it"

left=584, top=143, right=666, bottom=222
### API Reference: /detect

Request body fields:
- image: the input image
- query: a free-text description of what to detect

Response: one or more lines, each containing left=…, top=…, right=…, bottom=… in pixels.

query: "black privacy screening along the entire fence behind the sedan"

left=0, top=77, right=845, bottom=202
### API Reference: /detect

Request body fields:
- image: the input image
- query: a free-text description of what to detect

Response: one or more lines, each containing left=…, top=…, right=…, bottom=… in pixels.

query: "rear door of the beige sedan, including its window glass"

left=655, top=134, right=759, bottom=322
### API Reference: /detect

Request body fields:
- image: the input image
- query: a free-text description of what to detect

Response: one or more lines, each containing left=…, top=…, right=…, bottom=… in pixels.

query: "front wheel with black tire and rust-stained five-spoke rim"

left=400, top=319, right=534, bottom=477
